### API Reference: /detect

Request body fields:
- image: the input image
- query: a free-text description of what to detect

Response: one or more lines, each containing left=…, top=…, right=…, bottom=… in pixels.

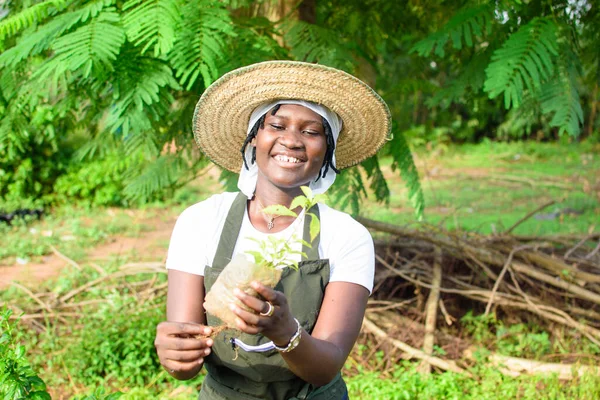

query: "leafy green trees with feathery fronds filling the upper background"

left=0, top=0, right=600, bottom=215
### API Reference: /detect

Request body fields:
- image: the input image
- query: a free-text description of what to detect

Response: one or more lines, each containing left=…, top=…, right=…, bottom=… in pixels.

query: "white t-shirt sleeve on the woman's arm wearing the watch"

left=329, top=215, right=375, bottom=293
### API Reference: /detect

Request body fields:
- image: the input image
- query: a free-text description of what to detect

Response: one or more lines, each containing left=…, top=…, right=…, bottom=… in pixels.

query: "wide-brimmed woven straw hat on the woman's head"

left=193, top=61, right=392, bottom=173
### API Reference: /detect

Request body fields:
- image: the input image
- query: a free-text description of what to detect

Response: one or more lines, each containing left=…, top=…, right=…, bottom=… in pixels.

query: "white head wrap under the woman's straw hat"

left=238, top=100, right=342, bottom=199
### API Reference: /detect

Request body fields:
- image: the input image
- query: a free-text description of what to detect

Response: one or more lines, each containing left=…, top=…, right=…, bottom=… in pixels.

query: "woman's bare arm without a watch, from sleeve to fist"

left=154, top=270, right=213, bottom=380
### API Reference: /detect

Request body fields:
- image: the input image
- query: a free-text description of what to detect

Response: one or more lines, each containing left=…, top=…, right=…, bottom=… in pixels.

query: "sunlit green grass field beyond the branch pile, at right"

left=361, top=142, right=600, bottom=235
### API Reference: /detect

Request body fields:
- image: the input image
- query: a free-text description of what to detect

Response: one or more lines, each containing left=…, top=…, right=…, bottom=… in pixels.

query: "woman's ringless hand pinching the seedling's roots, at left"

left=154, top=321, right=213, bottom=380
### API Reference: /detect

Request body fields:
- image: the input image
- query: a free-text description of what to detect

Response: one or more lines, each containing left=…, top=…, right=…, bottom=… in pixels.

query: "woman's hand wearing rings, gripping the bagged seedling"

left=230, top=282, right=298, bottom=347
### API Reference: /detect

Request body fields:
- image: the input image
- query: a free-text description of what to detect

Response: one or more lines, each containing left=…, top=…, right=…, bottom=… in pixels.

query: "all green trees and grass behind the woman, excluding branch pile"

left=0, top=0, right=600, bottom=400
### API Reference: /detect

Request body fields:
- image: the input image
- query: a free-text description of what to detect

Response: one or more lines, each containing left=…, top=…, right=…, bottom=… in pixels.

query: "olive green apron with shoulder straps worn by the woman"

left=199, top=193, right=347, bottom=400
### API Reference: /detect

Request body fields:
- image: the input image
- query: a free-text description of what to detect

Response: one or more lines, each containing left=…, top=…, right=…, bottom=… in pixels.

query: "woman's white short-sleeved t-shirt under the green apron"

left=162, top=193, right=375, bottom=292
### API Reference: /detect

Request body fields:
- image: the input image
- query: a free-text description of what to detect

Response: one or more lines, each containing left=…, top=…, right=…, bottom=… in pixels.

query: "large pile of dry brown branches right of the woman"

left=360, top=219, right=600, bottom=377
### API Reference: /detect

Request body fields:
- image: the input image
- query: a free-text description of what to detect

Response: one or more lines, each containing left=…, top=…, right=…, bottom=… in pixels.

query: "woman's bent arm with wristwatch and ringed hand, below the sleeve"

left=232, top=282, right=369, bottom=386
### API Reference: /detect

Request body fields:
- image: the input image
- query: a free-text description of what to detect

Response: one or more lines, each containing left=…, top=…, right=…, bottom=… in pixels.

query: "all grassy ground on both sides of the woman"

left=0, top=142, right=600, bottom=400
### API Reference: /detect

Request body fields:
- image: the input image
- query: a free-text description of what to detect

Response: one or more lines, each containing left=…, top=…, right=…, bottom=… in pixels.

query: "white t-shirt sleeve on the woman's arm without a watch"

left=166, top=198, right=215, bottom=275
